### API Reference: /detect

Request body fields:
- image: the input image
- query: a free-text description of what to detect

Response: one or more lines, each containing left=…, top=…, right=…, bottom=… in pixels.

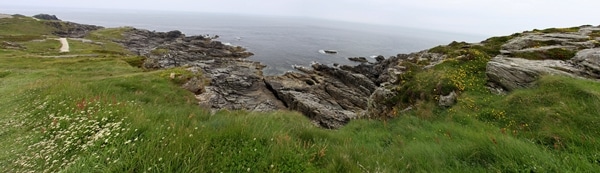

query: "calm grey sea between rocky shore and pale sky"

left=0, top=7, right=484, bottom=75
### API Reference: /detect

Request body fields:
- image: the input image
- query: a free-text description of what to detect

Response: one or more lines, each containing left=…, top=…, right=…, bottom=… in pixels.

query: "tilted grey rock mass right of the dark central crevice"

left=265, top=51, right=454, bottom=128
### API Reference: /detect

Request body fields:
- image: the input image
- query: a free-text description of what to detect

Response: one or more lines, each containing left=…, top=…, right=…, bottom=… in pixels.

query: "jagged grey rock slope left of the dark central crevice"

left=119, top=29, right=285, bottom=111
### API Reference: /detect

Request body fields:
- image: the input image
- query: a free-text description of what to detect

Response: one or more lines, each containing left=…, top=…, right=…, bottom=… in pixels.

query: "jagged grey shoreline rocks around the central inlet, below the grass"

left=119, top=26, right=458, bottom=128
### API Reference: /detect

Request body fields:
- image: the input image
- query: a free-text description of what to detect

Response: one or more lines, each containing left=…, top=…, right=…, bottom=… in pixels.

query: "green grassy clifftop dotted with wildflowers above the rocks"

left=0, top=14, right=600, bottom=172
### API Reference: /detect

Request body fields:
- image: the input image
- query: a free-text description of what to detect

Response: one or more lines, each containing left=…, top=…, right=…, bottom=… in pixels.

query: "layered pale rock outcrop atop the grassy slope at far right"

left=486, top=26, right=600, bottom=93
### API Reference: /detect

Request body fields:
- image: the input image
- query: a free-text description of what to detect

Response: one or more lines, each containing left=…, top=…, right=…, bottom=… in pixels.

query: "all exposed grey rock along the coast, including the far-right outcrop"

left=36, top=14, right=600, bottom=129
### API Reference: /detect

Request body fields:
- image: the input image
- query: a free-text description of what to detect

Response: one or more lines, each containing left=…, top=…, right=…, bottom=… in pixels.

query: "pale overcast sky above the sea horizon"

left=0, top=0, right=600, bottom=36
